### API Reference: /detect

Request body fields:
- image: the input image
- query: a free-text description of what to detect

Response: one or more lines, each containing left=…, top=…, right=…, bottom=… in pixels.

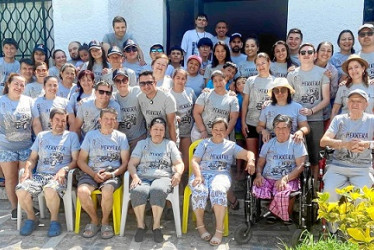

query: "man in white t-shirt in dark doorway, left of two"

left=181, top=14, right=213, bottom=65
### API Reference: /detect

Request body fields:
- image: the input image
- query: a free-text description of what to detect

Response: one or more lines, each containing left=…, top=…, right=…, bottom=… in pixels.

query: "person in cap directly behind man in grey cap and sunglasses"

left=102, top=46, right=136, bottom=87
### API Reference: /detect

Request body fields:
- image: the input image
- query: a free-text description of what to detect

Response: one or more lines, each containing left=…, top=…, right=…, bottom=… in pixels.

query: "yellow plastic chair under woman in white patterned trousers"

left=182, top=140, right=229, bottom=236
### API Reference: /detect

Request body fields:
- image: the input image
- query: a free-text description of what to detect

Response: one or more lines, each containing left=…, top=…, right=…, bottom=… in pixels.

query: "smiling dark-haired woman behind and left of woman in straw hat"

left=330, top=30, right=355, bottom=82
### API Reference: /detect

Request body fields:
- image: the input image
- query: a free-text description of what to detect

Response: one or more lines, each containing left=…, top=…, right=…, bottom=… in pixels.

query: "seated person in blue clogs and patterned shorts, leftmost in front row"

left=16, top=108, right=79, bottom=237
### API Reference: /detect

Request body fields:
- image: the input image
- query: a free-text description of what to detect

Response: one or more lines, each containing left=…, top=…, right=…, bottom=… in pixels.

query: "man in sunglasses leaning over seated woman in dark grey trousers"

left=138, top=71, right=178, bottom=142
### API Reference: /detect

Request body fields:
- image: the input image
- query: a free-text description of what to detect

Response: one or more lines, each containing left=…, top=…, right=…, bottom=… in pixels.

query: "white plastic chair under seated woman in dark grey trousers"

left=119, top=171, right=182, bottom=237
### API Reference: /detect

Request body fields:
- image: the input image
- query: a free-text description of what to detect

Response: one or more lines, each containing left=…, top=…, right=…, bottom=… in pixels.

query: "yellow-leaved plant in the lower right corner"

left=316, top=186, right=374, bottom=250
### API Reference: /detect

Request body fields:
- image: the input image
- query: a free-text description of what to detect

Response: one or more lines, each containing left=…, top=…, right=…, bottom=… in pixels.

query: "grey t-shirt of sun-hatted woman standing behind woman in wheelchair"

left=260, top=101, right=307, bottom=134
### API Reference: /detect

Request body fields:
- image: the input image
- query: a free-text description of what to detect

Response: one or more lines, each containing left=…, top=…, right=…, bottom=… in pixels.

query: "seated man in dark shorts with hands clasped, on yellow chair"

left=78, top=108, right=129, bottom=239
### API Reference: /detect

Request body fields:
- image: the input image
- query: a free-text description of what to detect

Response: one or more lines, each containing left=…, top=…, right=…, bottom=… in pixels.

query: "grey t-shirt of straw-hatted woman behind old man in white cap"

left=334, top=83, right=374, bottom=114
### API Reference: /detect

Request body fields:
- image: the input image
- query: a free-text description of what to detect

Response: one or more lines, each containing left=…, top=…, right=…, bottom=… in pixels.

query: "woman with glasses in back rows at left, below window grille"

left=23, top=62, right=49, bottom=99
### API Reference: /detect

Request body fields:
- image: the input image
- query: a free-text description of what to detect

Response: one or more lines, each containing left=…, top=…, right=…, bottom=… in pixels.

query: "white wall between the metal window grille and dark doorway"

left=52, top=0, right=166, bottom=61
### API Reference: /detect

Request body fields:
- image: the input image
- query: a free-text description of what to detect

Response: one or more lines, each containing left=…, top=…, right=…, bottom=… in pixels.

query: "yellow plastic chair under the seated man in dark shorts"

left=75, top=185, right=123, bottom=235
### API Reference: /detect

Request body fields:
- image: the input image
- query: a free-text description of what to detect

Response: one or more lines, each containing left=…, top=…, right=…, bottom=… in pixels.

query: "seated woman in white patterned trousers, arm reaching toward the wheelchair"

left=189, top=118, right=255, bottom=246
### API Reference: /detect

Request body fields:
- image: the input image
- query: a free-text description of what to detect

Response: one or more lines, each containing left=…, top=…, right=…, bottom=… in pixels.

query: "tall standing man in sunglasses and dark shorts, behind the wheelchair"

left=287, top=43, right=330, bottom=179
